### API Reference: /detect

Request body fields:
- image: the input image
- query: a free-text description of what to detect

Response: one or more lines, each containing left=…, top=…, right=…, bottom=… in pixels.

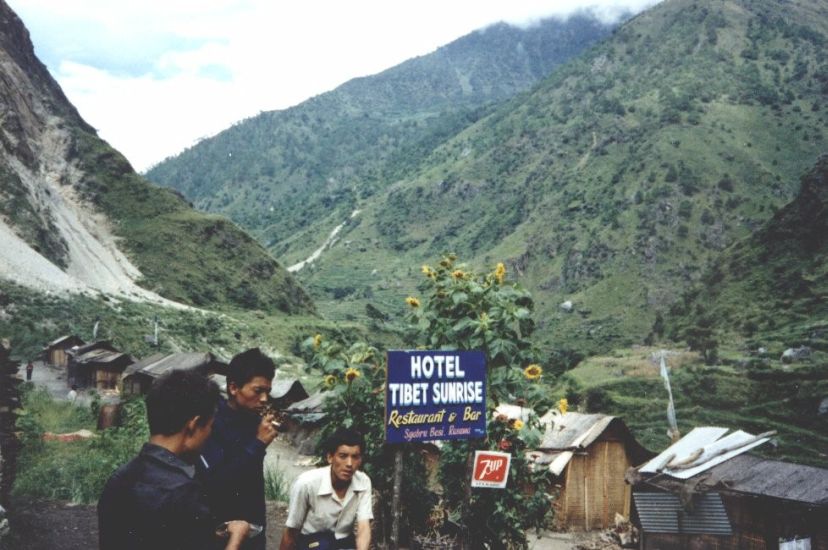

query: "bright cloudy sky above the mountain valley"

left=7, top=0, right=659, bottom=172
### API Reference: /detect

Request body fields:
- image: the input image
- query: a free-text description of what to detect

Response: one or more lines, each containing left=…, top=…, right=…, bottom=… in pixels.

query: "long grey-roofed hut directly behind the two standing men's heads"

left=122, top=352, right=227, bottom=395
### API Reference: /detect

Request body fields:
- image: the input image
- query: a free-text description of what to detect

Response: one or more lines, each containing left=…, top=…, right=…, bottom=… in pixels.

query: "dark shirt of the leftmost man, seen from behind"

left=98, top=443, right=218, bottom=550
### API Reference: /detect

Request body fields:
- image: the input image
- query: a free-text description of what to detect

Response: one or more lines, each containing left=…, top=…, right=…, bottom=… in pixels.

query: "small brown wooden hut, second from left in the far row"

left=67, top=340, right=135, bottom=390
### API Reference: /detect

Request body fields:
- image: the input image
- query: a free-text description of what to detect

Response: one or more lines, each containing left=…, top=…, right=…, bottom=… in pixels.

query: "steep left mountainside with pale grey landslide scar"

left=0, top=2, right=313, bottom=312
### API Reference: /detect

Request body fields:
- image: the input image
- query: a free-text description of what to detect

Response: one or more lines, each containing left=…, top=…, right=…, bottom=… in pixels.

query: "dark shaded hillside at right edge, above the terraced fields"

left=669, top=155, right=828, bottom=351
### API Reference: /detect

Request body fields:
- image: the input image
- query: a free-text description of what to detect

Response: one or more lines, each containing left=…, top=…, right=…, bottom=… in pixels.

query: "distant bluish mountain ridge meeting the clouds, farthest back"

left=147, top=15, right=610, bottom=262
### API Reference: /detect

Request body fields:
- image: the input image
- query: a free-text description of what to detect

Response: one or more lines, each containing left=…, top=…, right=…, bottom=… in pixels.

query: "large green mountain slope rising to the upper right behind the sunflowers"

left=292, top=0, right=828, bottom=353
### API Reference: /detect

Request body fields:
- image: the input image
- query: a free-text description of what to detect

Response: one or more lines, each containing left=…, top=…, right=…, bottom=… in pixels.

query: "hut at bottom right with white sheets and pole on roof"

left=631, top=427, right=828, bottom=550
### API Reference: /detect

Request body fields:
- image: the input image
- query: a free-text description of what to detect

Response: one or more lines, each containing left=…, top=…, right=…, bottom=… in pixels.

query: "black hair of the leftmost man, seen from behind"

left=146, top=370, right=219, bottom=435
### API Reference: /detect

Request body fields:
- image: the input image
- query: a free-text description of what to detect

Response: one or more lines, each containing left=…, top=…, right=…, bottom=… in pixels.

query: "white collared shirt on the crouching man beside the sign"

left=285, top=466, right=374, bottom=539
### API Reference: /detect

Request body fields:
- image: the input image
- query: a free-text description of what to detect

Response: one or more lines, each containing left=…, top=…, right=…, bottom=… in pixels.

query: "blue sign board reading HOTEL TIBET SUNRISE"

left=385, top=350, right=486, bottom=443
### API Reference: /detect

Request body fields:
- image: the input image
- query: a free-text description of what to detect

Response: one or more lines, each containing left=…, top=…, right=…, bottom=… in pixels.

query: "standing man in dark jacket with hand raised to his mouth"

left=197, top=348, right=277, bottom=550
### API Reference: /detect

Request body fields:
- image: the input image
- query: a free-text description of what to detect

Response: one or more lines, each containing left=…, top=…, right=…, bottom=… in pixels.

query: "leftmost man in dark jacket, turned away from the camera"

left=98, top=371, right=249, bottom=550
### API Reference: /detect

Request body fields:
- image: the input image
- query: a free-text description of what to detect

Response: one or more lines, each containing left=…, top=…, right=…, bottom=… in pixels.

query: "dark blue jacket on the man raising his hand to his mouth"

left=197, top=401, right=266, bottom=549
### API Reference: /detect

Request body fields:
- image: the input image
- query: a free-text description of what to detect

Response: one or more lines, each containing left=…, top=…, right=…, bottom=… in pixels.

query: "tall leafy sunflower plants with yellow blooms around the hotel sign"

left=304, top=254, right=549, bottom=548
